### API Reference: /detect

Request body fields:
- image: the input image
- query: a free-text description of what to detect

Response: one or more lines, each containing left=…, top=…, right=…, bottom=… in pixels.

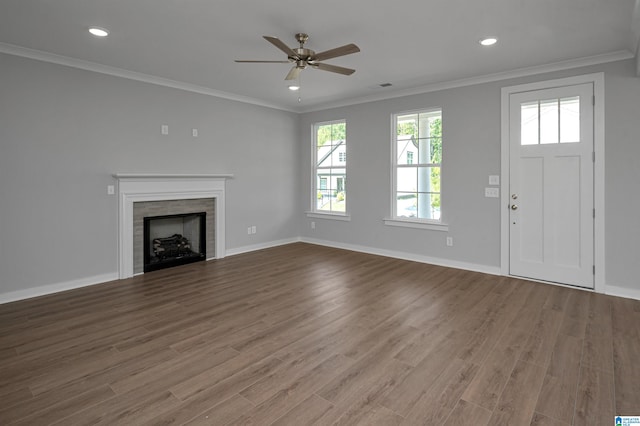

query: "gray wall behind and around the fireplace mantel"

left=0, top=54, right=300, bottom=296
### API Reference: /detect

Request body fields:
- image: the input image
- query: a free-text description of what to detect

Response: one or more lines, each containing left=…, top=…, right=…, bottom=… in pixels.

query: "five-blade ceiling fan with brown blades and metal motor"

left=236, top=33, right=360, bottom=80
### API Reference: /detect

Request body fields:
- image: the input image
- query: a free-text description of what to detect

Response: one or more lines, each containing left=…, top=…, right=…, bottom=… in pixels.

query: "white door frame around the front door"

left=500, top=73, right=605, bottom=293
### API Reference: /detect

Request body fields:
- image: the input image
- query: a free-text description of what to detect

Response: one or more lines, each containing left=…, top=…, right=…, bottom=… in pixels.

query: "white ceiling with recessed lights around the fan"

left=0, top=0, right=640, bottom=111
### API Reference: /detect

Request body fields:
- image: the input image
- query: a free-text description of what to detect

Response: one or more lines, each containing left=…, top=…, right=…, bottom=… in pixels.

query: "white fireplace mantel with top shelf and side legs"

left=113, top=173, right=233, bottom=279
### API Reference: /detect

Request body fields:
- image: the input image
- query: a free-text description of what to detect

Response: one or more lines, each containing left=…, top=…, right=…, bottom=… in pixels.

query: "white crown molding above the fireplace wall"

left=0, top=42, right=298, bottom=112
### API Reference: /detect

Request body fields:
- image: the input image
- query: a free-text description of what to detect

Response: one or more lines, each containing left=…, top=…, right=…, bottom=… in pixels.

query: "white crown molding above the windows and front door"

left=298, top=50, right=635, bottom=113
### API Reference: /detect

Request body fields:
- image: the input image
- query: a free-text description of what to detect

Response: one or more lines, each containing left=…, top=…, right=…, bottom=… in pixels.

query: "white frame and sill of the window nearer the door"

left=384, top=107, right=449, bottom=232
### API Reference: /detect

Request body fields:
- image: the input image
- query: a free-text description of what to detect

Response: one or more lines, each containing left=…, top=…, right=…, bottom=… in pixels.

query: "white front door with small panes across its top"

left=509, top=83, right=594, bottom=288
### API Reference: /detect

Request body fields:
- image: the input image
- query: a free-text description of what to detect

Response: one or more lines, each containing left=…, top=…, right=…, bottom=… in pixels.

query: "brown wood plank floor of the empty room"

left=0, top=243, right=640, bottom=426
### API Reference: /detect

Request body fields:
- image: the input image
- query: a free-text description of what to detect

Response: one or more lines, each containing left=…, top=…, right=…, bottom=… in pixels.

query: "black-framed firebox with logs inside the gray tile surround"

left=143, top=212, right=207, bottom=272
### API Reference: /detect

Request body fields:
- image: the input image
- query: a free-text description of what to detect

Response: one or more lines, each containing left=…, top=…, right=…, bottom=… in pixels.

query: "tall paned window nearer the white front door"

left=393, top=109, right=442, bottom=222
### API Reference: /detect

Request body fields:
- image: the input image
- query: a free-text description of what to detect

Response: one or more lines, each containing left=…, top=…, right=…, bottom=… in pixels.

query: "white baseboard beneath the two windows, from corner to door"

left=300, top=238, right=501, bottom=275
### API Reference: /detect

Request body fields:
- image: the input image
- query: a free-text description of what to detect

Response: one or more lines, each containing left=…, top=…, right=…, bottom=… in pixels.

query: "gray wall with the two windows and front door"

left=298, top=60, right=640, bottom=295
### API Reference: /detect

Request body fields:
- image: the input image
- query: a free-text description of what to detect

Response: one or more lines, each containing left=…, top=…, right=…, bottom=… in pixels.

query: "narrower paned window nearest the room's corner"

left=313, top=120, right=347, bottom=215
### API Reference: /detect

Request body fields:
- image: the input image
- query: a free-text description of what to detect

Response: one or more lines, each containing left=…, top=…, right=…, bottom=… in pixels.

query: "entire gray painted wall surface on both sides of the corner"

left=0, top=54, right=640, bottom=299
